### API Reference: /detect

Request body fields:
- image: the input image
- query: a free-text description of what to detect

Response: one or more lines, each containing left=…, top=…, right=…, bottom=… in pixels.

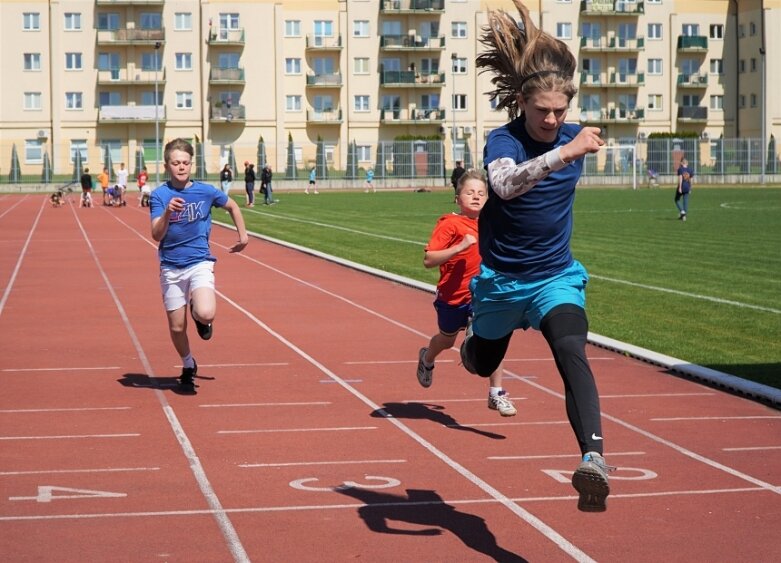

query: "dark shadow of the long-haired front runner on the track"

left=336, top=487, right=526, bottom=563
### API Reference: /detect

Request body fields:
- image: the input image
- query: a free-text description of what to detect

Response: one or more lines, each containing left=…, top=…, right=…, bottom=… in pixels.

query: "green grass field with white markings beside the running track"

left=222, top=188, right=781, bottom=388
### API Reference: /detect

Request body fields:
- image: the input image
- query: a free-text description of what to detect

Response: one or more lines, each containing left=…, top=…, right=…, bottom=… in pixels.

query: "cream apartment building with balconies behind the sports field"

left=0, top=0, right=781, bottom=177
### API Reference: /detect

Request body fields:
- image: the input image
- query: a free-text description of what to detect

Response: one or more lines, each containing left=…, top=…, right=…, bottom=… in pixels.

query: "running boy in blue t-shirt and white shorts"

left=150, top=139, right=249, bottom=393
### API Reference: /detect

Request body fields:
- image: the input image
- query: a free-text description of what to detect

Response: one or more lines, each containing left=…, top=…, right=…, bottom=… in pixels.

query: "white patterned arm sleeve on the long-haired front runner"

left=488, top=147, right=567, bottom=199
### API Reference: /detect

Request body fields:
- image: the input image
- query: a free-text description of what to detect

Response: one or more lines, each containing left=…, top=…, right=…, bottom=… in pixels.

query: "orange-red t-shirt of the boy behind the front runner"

left=426, top=213, right=480, bottom=305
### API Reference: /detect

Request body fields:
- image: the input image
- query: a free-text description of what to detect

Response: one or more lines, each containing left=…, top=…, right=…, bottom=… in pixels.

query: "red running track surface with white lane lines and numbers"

left=0, top=196, right=781, bottom=562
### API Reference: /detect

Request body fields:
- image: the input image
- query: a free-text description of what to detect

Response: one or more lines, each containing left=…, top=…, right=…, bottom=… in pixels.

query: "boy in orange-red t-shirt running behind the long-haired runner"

left=418, top=170, right=517, bottom=416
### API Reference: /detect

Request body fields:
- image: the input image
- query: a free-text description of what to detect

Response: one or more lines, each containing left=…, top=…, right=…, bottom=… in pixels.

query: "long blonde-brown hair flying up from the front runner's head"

left=476, top=0, right=578, bottom=119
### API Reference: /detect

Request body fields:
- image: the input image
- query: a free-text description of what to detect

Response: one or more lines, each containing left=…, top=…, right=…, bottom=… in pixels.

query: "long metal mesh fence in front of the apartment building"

left=0, top=136, right=781, bottom=184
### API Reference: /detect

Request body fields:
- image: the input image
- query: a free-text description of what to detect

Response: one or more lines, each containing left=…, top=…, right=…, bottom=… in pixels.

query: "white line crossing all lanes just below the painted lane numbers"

left=0, top=487, right=767, bottom=522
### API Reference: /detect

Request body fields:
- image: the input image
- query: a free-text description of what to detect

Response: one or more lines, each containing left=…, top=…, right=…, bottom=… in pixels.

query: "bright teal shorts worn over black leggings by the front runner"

left=469, top=260, right=588, bottom=340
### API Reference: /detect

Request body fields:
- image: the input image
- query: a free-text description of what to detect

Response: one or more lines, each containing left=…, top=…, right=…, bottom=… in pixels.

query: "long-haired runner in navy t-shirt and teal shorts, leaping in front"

left=461, top=0, right=611, bottom=512
